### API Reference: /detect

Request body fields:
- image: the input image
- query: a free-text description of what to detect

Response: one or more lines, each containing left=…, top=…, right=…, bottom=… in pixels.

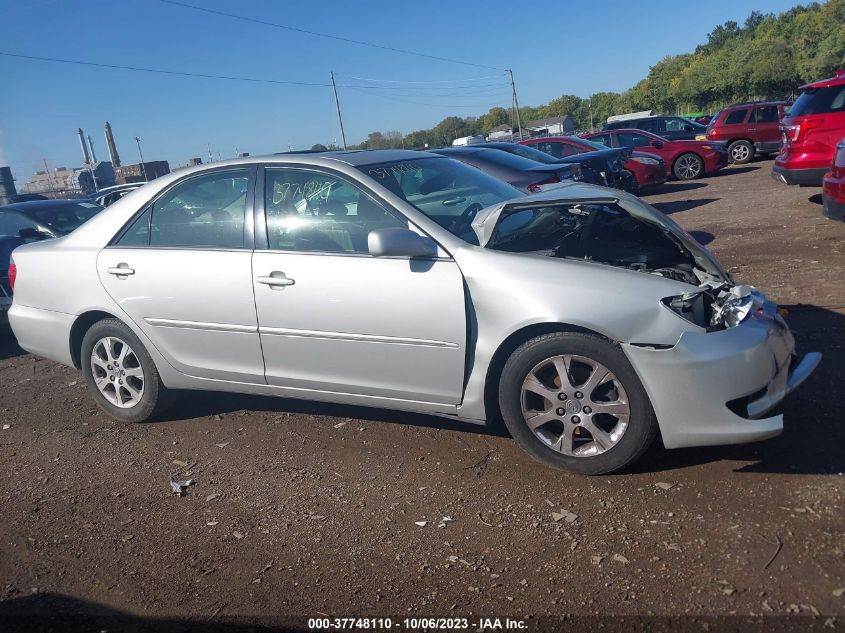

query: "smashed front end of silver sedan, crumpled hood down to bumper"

left=473, top=185, right=820, bottom=448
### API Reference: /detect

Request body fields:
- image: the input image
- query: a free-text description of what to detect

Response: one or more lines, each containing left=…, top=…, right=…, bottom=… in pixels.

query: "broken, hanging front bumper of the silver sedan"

left=622, top=303, right=821, bottom=448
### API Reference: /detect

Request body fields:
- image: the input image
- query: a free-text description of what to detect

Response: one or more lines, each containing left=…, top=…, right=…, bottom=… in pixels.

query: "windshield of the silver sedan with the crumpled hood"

left=358, top=152, right=525, bottom=244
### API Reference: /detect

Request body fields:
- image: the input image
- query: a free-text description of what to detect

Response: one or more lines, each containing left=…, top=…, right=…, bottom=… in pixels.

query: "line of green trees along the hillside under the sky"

left=314, top=0, right=845, bottom=149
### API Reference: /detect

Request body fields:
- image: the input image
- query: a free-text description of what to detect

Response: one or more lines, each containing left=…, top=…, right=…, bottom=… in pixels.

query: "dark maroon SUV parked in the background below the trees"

left=707, top=101, right=792, bottom=163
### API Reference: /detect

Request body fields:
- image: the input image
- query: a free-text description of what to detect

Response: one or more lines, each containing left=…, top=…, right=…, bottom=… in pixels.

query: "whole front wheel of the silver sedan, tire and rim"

left=499, top=332, right=657, bottom=475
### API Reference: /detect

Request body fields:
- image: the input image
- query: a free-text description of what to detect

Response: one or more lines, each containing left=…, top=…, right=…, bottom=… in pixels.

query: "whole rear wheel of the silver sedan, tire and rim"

left=80, top=319, right=167, bottom=422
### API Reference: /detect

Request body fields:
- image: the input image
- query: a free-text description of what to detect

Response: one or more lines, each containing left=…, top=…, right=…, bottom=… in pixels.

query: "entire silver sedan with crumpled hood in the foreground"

left=10, top=150, right=820, bottom=474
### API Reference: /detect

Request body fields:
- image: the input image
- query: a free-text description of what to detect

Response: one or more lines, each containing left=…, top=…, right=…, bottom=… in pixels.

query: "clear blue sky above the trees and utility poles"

left=0, top=0, right=796, bottom=182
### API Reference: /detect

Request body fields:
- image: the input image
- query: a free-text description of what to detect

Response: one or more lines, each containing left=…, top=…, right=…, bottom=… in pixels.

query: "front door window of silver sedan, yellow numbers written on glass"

left=264, top=168, right=408, bottom=253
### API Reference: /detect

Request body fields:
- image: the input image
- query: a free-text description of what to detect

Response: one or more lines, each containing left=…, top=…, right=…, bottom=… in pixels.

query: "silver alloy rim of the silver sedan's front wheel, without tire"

left=521, top=354, right=631, bottom=457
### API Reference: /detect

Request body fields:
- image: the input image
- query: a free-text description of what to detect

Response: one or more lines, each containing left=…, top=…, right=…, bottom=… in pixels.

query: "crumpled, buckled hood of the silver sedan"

left=472, top=183, right=732, bottom=283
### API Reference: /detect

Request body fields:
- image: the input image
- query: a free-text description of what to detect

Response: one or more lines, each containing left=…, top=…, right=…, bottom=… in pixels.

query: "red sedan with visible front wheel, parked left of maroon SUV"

left=584, top=130, right=728, bottom=180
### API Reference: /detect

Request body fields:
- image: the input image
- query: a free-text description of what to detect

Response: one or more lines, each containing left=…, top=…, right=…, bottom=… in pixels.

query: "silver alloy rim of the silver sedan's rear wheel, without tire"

left=91, top=336, right=144, bottom=409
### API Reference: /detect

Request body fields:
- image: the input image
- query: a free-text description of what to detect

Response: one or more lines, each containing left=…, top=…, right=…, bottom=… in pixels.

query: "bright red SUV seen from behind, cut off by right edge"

left=772, top=70, right=845, bottom=187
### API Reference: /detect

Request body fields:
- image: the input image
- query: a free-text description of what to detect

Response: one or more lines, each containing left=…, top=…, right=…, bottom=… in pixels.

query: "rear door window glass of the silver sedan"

left=148, top=169, right=249, bottom=248
